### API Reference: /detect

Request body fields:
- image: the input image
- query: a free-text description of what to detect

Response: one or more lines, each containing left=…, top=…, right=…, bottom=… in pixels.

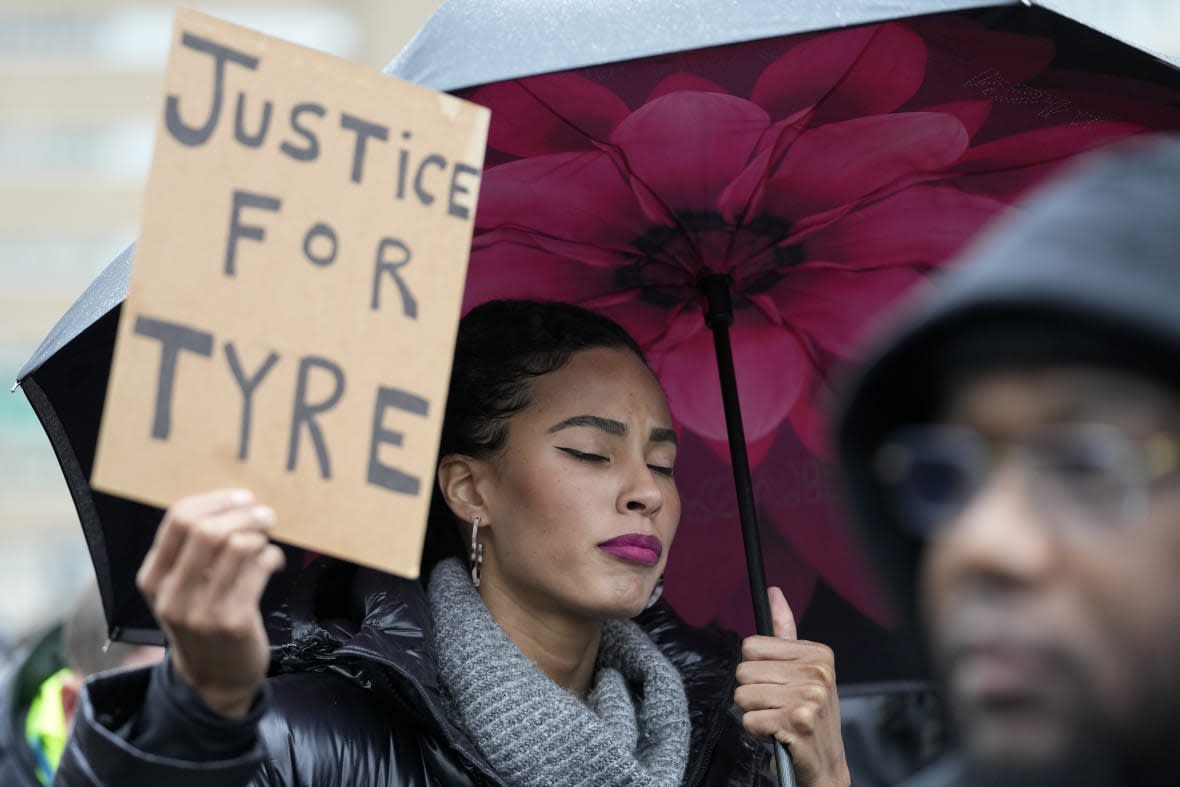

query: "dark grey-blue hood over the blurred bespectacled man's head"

left=835, top=137, right=1180, bottom=670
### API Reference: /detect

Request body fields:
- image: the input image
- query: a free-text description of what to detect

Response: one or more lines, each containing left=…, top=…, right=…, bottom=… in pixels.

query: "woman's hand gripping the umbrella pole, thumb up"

left=734, top=588, right=852, bottom=787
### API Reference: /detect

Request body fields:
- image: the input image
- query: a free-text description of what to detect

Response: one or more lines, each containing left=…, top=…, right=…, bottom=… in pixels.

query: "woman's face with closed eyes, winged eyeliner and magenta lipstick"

left=480, top=348, right=680, bottom=618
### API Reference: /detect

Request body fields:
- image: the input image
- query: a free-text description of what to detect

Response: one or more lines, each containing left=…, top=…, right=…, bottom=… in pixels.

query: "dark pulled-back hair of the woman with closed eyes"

left=422, top=301, right=647, bottom=577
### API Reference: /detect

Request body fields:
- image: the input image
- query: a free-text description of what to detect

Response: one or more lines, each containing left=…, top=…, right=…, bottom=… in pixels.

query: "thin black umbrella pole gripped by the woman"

left=701, top=274, right=795, bottom=787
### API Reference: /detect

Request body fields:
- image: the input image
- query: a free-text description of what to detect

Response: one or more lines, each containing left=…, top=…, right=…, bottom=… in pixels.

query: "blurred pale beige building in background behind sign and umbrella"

left=0, top=0, right=1180, bottom=651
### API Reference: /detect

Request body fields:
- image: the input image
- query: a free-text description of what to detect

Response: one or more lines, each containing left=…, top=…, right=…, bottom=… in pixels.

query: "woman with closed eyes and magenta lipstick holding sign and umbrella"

left=59, top=301, right=848, bottom=787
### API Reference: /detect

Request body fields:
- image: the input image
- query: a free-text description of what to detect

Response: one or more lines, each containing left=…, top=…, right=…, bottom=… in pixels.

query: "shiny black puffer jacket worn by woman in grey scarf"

left=54, top=570, right=773, bottom=787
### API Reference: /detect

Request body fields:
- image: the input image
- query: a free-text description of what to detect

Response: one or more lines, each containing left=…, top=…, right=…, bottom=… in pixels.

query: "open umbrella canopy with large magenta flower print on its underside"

left=19, top=0, right=1180, bottom=683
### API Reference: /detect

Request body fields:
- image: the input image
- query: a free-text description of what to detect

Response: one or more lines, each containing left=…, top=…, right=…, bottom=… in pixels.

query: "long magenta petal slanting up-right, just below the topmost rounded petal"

left=766, top=112, right=968, bottom=218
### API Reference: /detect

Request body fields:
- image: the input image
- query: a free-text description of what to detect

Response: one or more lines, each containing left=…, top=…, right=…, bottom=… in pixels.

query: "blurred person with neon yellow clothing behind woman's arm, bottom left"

left=0, top=584, right=164, bottom=787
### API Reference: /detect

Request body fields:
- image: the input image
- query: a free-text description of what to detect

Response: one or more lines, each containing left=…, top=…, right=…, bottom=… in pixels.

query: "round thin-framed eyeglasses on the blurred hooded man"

left=874, top=424, right=1180, bottom=538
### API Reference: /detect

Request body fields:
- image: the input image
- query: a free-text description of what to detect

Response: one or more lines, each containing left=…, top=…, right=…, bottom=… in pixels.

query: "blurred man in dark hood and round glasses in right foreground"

left=838, top=139, right=1180, bottom=787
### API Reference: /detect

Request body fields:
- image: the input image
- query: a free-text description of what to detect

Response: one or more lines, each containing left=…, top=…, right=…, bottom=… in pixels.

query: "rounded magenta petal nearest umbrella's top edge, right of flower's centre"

left=752, top=24, right=926, bottom=123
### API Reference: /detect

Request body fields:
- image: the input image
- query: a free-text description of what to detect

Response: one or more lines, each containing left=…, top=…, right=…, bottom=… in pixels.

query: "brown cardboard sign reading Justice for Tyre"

left=91, top=9, right=489, bottom=577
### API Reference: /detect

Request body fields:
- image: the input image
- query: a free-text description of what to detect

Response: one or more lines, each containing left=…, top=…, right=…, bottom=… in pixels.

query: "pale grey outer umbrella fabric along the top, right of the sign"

left=385, top=0, right=1180, bottom=91
